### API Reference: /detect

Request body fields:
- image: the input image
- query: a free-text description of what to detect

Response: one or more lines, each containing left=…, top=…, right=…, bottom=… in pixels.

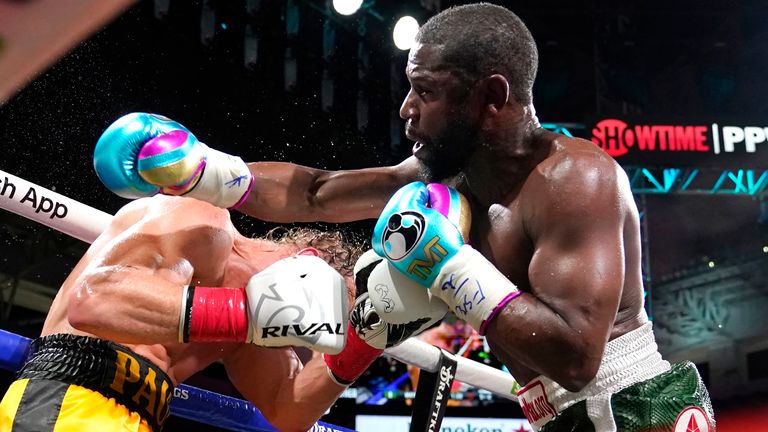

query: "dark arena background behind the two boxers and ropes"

left=0, top=0, right=768, bottom=430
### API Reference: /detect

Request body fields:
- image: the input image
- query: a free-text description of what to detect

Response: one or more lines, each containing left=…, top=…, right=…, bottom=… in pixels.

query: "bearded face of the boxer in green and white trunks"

left=400, top=44, right=480, bottom=181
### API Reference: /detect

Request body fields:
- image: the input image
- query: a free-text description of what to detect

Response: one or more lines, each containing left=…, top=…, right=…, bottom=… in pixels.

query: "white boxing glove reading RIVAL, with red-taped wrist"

left=179, top=255, right=349, bottom=353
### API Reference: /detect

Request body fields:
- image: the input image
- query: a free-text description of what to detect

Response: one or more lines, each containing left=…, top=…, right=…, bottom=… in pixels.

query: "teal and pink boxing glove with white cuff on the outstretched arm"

left=93, top=113, right=253, bottom=208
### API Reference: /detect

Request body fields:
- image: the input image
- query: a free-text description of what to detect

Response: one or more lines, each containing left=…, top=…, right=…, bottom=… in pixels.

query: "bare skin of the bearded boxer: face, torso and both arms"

left=240, top=22, right=636, bottom=391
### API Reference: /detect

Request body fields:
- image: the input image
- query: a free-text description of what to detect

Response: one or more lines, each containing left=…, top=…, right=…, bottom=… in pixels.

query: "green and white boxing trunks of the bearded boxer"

left=517, top=322, right=715, bottom=432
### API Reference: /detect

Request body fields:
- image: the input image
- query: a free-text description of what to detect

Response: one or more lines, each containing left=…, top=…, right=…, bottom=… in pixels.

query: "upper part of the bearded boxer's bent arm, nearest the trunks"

left=528, top=157, right=624, bottom=353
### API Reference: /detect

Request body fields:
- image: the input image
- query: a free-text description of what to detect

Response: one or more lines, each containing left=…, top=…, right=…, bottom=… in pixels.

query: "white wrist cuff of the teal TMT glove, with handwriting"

left=430, top=245, right=520, bottom=333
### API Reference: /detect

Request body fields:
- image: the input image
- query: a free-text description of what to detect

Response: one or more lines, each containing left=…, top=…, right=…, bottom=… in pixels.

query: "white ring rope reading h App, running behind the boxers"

left=0, top=170, right=517, bottom=401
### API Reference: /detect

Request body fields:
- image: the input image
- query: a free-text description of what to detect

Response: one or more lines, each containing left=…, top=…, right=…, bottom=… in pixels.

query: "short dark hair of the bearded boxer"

left=416, top=3, right=539, bottom=105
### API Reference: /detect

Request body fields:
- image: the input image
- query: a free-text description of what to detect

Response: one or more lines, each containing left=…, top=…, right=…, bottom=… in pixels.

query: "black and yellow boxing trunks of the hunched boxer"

left=0, top=334, right=174, bottom=432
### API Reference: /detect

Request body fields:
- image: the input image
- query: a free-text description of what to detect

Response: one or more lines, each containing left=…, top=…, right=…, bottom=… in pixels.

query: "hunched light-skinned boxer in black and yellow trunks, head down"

left=0, top=195, right=366, bottom=432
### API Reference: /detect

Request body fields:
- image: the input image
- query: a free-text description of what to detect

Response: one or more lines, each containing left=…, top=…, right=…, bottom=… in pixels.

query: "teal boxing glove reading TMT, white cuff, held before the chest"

left=372, top=182, right=521, bottom=334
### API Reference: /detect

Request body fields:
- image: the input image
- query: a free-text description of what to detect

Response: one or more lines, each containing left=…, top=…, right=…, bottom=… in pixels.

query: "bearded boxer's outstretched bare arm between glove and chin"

left=238, top=160, right=418, bottom=223
